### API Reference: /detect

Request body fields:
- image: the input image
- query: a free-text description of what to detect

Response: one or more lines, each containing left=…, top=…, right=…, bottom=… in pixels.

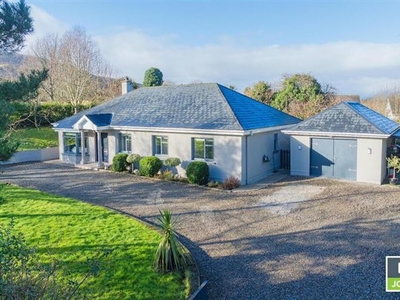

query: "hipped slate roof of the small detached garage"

left=288, top=102, right=400, bottom=135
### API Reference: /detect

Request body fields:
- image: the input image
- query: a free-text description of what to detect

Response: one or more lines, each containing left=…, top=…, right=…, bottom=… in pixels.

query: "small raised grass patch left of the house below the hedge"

left=6, top=127, right=58, bottom=151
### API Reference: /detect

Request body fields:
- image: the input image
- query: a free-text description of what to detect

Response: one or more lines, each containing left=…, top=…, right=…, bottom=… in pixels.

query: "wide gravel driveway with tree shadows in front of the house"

left=0, top=163, right=400, bottom=299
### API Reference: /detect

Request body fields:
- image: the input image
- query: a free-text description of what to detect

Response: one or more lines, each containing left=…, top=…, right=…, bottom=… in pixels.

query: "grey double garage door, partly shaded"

left=310, top=139, right=357, bottom=180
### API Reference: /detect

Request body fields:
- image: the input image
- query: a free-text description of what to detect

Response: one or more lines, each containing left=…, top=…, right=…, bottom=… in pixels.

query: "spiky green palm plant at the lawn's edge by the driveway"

left=154, top=210, right=192, bottom=273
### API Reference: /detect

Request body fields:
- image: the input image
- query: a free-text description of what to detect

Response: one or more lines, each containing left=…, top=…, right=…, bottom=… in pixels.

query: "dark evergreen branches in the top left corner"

left=0, top=0, right=33, bottom=54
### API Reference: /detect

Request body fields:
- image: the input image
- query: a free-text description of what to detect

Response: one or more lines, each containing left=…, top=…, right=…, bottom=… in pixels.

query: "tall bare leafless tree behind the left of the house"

left=28, top=27, right=114, bottom=113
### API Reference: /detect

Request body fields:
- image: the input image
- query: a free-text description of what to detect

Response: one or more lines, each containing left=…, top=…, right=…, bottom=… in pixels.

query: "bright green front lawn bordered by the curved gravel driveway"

left=0, top=185, right=187, bottom=299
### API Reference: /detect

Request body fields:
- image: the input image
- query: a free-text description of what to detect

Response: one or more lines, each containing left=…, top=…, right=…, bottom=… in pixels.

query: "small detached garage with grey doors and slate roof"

left=283, top=102, right=400, bottom=184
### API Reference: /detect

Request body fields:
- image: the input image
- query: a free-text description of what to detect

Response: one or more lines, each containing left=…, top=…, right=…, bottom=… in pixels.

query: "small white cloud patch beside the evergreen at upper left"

left=22, top=4, right=69, bottom=53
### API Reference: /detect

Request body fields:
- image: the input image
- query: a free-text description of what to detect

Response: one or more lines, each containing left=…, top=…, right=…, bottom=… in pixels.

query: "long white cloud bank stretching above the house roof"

left=95, top=30, right=400, bottom=96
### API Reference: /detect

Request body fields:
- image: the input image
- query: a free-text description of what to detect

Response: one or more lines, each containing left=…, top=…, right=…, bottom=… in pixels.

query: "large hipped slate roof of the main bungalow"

left=54, top=83, right=300, bottom=130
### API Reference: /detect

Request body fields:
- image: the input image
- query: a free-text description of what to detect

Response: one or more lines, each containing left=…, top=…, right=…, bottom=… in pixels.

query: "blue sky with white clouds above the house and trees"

left=23, top=0, right=400, bottom=98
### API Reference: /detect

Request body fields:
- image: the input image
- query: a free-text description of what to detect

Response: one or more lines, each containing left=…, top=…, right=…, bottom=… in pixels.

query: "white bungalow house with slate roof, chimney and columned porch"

left=53, top=82, right=300, bottom=184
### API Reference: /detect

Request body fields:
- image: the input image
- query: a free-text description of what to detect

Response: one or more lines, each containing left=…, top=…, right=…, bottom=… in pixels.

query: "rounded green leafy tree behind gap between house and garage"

left=271, top=74, right=333, bottom=119
